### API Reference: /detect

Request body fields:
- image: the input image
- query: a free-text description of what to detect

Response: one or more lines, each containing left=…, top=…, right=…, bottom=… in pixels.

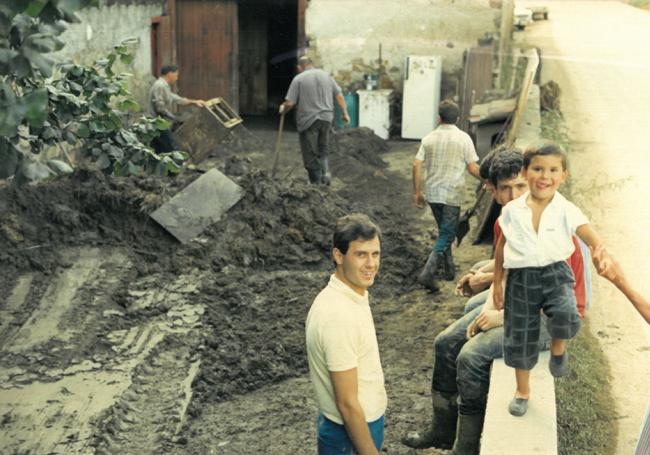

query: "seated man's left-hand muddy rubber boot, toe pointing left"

left=402, top=390, right=458, bottom=449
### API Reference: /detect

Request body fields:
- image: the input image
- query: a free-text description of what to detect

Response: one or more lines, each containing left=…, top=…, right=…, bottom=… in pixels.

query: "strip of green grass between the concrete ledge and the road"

left=542, top=108, right=616, bottom=455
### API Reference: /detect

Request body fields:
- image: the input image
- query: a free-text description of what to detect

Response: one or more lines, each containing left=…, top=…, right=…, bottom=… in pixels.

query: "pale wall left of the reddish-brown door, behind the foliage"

left=55, top=1, right=166, bottom=107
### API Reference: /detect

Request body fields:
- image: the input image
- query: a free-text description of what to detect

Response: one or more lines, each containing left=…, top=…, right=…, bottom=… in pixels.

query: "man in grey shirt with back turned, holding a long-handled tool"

left=279, top=57, right=350, bottom=185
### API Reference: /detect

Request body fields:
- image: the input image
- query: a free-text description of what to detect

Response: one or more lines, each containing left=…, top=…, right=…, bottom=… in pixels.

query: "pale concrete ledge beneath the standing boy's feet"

left=481, top=351, right=557, bottom=455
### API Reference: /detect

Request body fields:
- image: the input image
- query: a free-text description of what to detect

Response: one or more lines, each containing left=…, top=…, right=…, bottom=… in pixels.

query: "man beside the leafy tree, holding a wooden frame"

left=149, top=65, right=205, bottom=153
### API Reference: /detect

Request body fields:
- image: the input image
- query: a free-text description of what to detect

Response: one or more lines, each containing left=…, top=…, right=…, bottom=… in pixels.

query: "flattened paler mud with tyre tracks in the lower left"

left=0, top=248, right=204, bottom=454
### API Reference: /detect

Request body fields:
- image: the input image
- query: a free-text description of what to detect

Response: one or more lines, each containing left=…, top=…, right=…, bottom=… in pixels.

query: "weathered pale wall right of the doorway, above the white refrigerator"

left=305, top=0, right=500, bottom=91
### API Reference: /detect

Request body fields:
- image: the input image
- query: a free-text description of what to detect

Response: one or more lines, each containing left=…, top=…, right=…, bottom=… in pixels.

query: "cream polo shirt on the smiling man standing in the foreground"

left=305, top=275, right=388, bottom=424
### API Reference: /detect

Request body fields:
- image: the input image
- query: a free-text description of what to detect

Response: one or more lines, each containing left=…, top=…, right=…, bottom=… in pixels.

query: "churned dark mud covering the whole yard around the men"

left=0, top=123, right=489, bottom=454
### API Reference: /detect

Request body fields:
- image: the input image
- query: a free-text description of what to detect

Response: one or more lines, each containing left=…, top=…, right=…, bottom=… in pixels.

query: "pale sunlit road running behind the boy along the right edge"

left=526, top=1, right=650, bottom=455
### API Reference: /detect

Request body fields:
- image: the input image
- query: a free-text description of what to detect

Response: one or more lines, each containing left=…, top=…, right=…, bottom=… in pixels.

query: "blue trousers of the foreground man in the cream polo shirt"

left=316, top=413, right=384, bottom=455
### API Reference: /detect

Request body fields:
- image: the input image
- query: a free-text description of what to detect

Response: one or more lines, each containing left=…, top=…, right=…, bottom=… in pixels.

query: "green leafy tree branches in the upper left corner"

left=0, top=0, right=187, bottom=183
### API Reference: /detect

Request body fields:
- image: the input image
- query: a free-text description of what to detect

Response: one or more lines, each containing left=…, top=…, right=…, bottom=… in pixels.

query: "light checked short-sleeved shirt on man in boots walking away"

left=415, top=123, right=478, bottom=207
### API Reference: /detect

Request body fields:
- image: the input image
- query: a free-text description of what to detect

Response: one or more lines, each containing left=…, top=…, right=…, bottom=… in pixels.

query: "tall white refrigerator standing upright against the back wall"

left=402, top=55, right=442, bottom=139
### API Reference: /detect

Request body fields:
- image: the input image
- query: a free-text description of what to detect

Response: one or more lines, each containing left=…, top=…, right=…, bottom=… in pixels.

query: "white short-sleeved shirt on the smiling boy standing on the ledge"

left=499, top=192, right=589, bottom=269
